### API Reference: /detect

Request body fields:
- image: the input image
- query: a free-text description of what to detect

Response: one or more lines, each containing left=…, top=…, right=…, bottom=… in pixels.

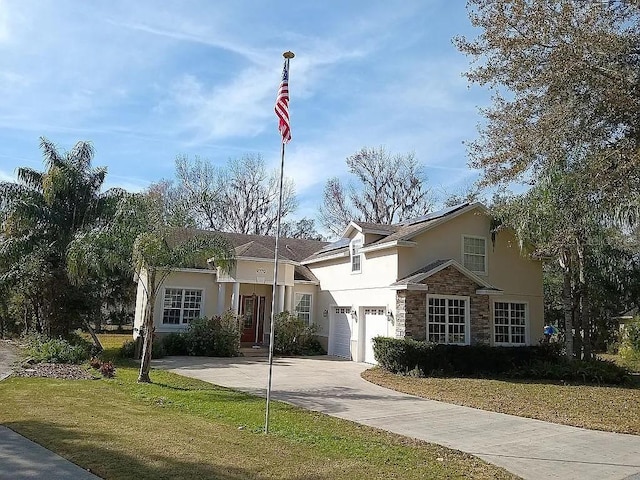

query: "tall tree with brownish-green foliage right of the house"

left=456, top=0, right=640, bottom=357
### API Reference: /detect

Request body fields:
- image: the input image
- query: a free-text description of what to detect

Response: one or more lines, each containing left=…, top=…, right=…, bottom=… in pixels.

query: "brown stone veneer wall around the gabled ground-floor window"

left=396, top=267, right=491, bottom=344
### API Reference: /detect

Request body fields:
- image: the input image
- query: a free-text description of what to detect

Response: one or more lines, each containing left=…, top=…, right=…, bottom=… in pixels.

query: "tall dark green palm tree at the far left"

left=0, top=138, right=118, bottom=335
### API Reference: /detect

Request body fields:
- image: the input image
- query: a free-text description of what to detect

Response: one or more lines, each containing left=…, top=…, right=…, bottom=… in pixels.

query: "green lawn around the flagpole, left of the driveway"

left=0, top=335, right=514, bottom=479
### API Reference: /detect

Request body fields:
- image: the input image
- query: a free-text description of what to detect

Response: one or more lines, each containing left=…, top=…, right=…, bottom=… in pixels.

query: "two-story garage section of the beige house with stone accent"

left=301, top=203, right=544, bottom=363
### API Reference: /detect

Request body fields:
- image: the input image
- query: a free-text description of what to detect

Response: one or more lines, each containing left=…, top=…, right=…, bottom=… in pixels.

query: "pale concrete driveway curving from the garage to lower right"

left=154, top=357, right=640, bottom=480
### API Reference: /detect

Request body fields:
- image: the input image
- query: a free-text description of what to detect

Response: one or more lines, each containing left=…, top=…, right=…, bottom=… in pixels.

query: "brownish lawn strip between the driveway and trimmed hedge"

left=362, top=368, right=640, bottom=435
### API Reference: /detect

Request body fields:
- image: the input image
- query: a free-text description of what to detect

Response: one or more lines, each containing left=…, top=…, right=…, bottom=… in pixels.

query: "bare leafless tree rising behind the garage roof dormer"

left=320, top=147, right=432, bottom=235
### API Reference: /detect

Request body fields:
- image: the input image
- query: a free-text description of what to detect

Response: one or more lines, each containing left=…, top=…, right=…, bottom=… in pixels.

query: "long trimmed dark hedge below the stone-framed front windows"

left=373, top=337, right=631, bottom=384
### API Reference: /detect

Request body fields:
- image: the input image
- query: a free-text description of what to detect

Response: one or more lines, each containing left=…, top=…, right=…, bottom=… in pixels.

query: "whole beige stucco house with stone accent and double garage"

left=136, top=203, right=544, bottom=363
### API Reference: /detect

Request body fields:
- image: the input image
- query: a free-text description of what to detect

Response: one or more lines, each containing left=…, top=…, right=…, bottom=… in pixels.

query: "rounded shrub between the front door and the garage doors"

left=273, top=312, right=326, bottom=355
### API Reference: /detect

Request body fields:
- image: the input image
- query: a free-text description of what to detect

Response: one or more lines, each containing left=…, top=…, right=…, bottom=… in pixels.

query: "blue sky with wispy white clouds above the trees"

left=0, top=0, right=488, bottom=217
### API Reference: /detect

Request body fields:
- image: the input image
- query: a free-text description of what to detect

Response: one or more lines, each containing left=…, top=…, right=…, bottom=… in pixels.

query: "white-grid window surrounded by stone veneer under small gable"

left=427, top=296, right=469, bottom=345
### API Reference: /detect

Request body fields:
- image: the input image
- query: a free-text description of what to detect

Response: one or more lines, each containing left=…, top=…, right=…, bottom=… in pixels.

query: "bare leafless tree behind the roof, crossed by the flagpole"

left=164, top=154, right=297, bottom=235
